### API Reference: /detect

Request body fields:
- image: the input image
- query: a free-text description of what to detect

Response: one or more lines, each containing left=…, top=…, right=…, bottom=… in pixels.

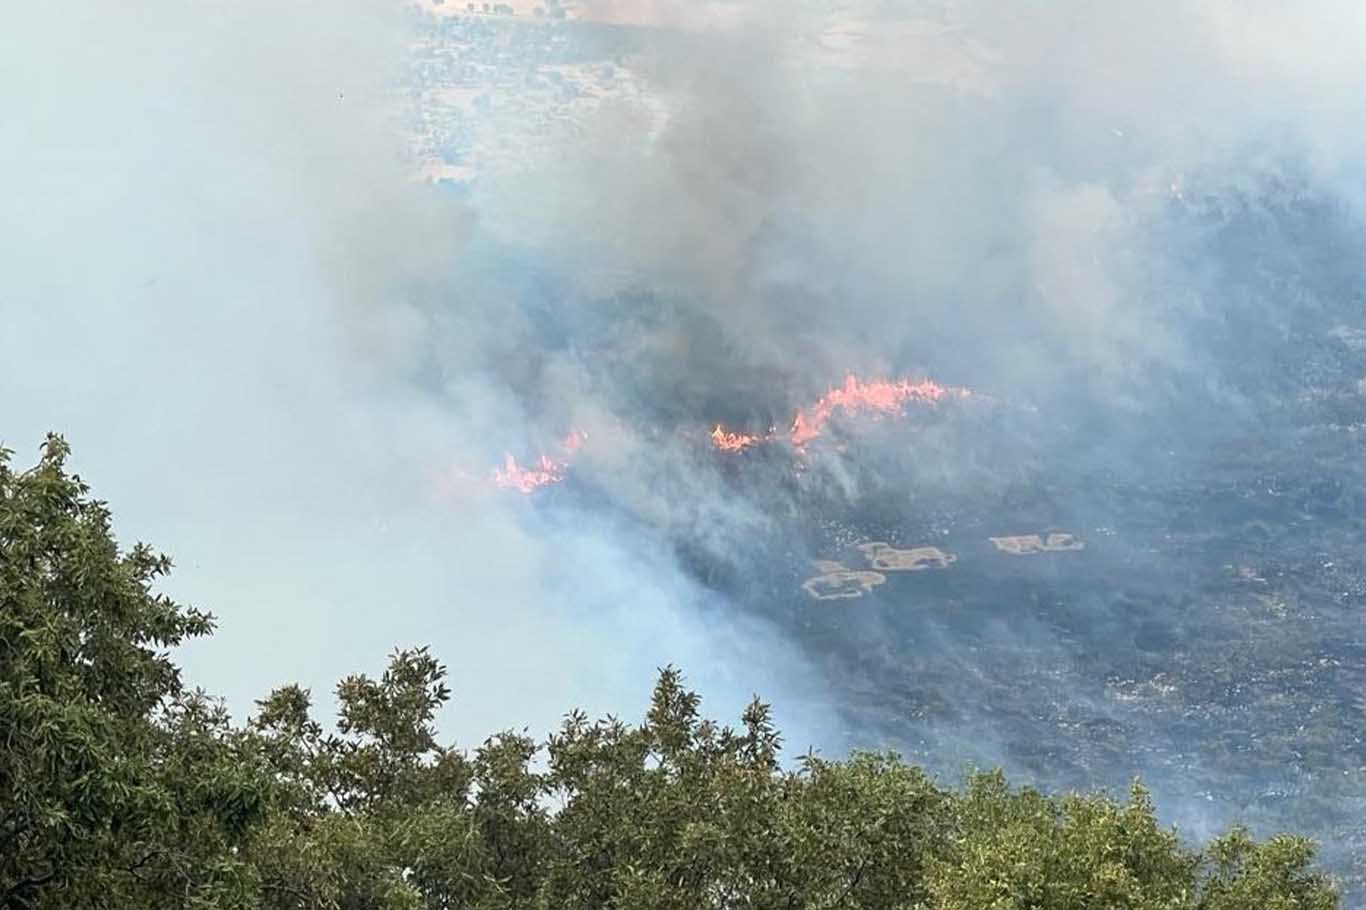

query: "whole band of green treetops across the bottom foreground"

left=0, top=436, right=1337, bottom=910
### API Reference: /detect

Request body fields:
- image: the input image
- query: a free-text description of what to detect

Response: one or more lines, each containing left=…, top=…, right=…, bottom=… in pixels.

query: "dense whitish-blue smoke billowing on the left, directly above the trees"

left=0, top=0, right=825, bottom=746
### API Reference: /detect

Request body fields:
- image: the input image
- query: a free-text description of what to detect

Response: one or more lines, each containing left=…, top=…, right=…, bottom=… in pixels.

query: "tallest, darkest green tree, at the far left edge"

left=0, top=436, right=264, bottom=907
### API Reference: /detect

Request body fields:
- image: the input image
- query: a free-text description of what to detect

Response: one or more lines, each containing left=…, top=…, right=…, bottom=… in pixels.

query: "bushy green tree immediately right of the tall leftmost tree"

left=250, top=649, right=481, bottom=910
